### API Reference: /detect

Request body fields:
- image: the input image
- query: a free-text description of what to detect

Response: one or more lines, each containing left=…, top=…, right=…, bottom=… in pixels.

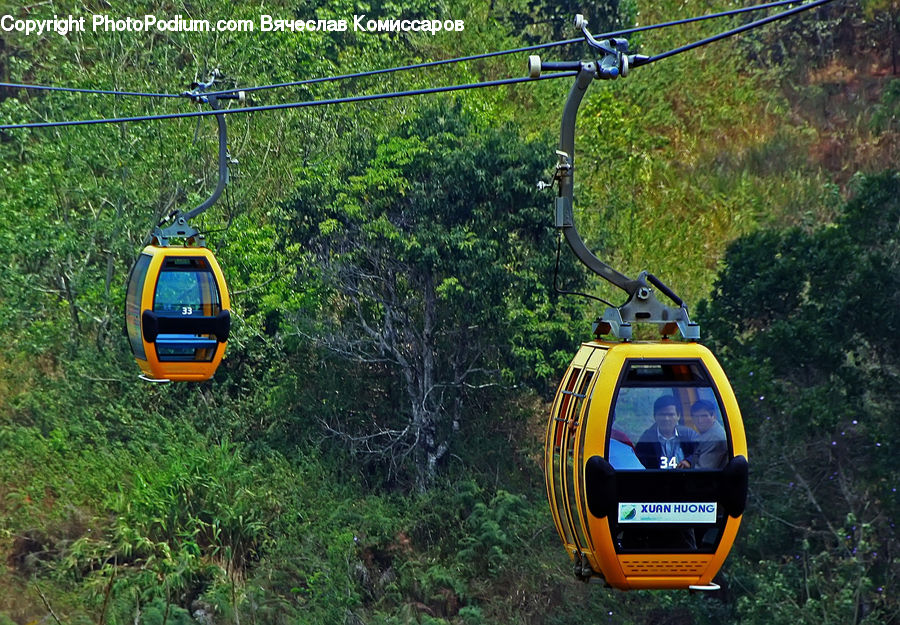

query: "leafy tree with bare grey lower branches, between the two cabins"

left=289, top=105, right=584, bottom=490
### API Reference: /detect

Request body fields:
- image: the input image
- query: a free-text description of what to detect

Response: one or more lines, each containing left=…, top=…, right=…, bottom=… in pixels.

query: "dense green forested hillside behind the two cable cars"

left=0, top=0, right=900, bottom=625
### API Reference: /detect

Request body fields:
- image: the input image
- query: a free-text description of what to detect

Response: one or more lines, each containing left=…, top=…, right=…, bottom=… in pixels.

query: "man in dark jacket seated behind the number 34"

left=635, top=395, right=697, bottom=469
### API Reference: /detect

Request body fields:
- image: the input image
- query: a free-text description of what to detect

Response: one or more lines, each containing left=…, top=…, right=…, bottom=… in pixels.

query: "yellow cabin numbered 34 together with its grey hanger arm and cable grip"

left=529, top=33, right=749, bottom=590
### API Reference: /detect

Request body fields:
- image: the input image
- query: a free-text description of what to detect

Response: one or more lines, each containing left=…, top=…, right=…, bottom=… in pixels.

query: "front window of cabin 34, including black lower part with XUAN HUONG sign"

left=607, top=361, right=731, bottom=553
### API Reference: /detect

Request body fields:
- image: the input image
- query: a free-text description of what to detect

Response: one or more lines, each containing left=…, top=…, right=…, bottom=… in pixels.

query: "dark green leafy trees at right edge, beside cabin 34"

left=700, top=172, right=900, bottom=623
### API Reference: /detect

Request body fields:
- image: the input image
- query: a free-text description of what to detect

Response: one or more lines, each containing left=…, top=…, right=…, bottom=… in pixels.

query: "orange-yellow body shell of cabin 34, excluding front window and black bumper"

left=545, top=341, right=747, bottom=589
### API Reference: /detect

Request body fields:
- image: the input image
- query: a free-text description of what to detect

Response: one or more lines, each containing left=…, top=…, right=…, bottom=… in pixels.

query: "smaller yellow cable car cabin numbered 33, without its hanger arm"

left=125, top=245, right=231, bottom=382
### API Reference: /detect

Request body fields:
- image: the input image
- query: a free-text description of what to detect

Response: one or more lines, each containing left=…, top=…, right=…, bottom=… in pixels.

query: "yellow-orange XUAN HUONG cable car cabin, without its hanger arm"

left=544, top=341, right=748, bottom=590
